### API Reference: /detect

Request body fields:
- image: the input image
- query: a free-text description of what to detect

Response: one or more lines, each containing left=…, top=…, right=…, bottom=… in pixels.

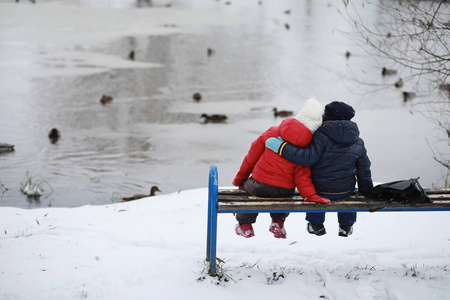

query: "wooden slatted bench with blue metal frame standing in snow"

left=206, top=165, right=450, bottom=276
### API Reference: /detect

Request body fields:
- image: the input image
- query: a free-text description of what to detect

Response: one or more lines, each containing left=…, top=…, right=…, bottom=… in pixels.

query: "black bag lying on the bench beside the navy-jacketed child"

left=365, top=178, right=431, bottom=212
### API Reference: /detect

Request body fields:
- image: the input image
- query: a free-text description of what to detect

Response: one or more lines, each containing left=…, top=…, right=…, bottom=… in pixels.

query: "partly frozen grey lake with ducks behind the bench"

left=0, top=0, right=448, bottom=208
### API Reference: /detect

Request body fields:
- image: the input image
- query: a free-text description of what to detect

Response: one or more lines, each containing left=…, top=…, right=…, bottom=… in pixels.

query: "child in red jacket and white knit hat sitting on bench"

left=233, top=98, right=330, bottom=238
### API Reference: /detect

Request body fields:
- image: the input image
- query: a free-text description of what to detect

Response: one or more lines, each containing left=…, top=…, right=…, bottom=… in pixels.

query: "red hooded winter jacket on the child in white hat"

left=233, top=118, right=316, bottom=198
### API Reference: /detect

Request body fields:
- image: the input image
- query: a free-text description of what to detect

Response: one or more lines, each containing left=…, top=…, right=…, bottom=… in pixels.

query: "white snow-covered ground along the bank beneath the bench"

left=0, top=189, right=450, bottom=300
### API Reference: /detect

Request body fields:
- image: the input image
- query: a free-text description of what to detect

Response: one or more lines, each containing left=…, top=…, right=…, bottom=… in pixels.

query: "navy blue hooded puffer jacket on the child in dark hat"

left=281, top=120, right=373, bottom=199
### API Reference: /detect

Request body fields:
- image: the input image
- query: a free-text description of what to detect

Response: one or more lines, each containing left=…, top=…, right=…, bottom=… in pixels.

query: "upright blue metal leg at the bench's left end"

left=206, top=165, right=219, bottom=276
